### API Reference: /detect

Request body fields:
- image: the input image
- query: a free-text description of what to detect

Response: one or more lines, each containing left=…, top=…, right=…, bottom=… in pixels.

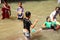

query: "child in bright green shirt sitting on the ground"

left=42, top=16, right=56, bottom=30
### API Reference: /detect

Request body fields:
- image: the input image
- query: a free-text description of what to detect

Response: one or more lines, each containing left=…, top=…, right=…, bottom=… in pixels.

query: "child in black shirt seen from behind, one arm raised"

left=23, top=11, right=38, bottom=40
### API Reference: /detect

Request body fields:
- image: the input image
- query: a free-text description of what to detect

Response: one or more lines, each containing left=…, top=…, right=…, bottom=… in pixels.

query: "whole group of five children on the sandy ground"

left=2, top=1, right=60, bottom=40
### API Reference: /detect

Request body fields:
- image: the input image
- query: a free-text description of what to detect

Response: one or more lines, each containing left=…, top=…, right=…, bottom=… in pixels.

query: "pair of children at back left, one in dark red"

left=1, top=1, right=24, bottom=20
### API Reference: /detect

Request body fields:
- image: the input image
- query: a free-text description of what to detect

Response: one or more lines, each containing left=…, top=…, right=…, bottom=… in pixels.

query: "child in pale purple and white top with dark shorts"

left=17, top=2, right=24, bottom=20
